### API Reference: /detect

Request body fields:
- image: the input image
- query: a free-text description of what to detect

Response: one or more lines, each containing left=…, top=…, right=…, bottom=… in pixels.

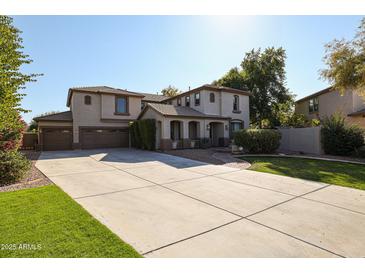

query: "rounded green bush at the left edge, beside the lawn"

left=0, top=151, right=31, bottom=186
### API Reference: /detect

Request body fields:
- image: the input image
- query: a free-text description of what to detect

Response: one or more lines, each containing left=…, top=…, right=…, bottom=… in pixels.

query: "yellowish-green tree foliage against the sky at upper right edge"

left=320, top=18, right=365, bottom=96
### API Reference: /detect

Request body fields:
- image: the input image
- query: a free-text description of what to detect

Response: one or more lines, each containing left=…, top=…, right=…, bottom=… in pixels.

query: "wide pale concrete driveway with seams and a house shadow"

left=37, top=149, right=365, bottom=257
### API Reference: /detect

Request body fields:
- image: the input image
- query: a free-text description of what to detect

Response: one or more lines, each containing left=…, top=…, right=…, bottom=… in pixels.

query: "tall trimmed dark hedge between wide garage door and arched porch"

left=129, top=119, right=156, bottom=150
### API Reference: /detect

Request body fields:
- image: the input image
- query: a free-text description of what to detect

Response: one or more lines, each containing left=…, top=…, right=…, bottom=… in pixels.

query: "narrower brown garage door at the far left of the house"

left=42, top=128, right=72, bottom=150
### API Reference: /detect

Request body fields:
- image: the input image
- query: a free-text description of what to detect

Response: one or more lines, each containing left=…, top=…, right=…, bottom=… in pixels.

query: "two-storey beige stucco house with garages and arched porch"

left=34, top=85, right=249, bottom=150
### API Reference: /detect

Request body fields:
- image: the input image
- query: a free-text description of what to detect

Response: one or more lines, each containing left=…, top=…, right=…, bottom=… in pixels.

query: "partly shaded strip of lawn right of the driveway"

left=241, top=156, right=365, bottom=190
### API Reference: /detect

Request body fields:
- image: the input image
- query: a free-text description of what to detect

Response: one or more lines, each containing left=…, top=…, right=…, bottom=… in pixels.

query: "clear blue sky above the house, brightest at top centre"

left=14, top=16, right=362, bottom=122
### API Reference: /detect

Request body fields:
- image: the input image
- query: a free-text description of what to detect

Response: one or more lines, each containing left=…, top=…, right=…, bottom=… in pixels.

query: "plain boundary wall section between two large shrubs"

left=279, top=126, right=323, bottom=154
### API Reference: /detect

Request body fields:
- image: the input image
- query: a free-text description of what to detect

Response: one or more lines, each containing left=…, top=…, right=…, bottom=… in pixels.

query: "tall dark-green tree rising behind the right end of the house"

left=213, top=47, right=294, bottom=128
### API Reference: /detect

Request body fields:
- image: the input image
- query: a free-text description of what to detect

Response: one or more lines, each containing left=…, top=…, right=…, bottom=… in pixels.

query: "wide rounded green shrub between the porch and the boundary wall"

left=234, top=129, right=281, bottom=153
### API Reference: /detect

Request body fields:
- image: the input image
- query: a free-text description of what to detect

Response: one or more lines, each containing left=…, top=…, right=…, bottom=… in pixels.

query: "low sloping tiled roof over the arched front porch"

left=138, top=103, right=230, bottom=120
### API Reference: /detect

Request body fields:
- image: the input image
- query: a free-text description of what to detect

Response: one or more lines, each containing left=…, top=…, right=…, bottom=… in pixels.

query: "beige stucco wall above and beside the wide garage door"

left=71, top=92, right=134, bottom=143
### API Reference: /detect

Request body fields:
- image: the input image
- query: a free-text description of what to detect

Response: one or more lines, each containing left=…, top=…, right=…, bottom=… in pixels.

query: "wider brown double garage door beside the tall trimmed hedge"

left=80, top=128, right=129, bottom=149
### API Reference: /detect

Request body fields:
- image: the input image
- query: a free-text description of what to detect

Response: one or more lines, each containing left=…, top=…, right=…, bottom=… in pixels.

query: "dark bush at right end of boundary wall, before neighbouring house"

left=321, top=114, right=364, bottom=156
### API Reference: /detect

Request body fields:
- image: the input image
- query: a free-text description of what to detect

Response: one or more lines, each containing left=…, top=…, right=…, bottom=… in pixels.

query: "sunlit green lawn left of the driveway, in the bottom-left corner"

left=0, top=185, right=140, bottom=258
